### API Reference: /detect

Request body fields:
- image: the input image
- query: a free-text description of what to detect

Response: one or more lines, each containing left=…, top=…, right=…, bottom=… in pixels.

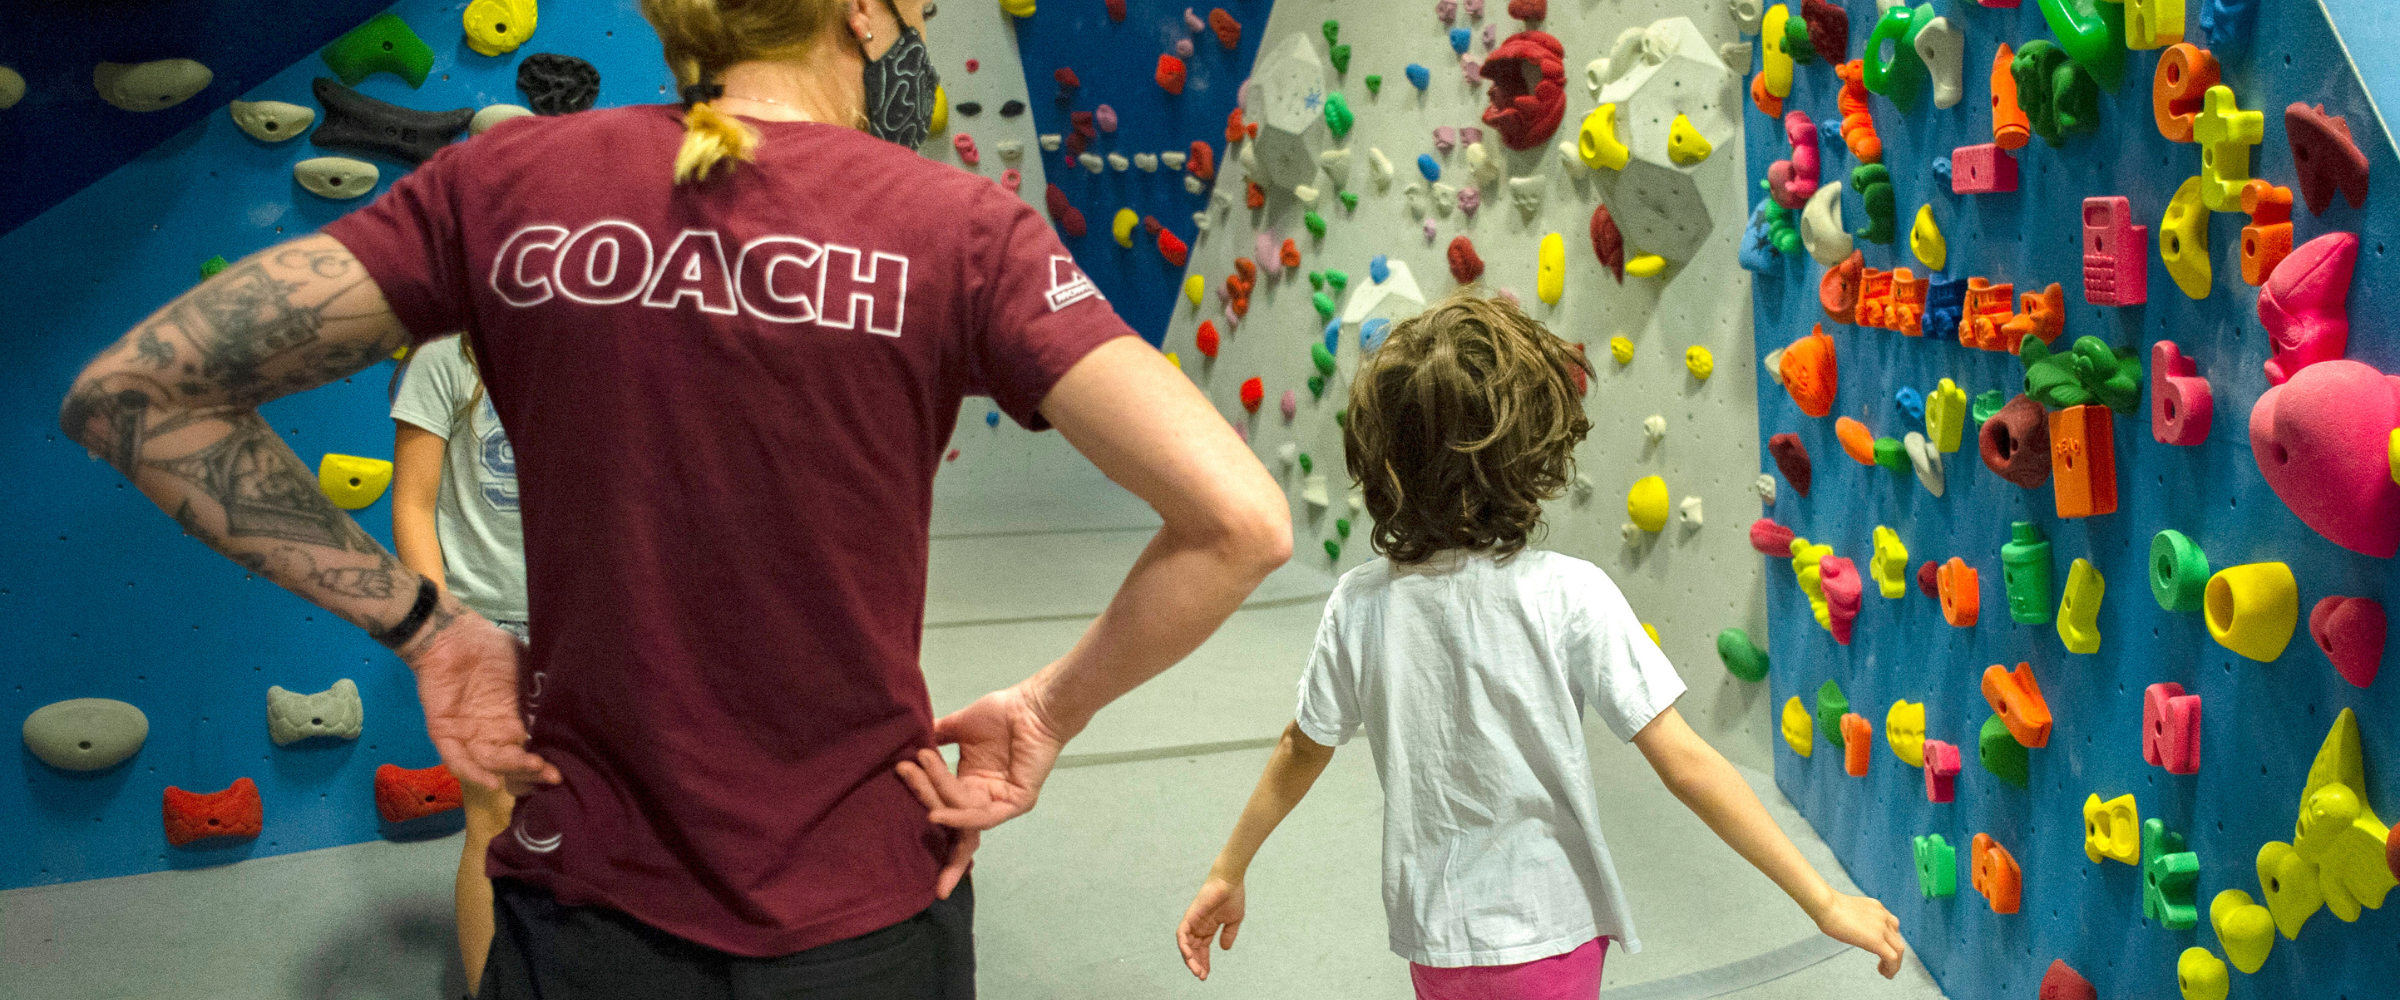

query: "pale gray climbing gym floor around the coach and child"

left=0, top=479, right=1942, bottom=1000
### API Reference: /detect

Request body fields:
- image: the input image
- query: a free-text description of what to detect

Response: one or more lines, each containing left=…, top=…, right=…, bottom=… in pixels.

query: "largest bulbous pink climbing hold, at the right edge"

left=2251, top=357, right=2400, bottom=559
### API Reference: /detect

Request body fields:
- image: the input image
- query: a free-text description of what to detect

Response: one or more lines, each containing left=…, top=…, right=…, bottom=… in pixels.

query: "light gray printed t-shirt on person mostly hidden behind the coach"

left=391, top=336, right=526, bottom=621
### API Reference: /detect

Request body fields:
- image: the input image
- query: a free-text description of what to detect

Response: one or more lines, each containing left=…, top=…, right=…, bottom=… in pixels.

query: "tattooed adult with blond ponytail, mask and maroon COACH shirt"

left=60, top=0, right=1291, bottom=998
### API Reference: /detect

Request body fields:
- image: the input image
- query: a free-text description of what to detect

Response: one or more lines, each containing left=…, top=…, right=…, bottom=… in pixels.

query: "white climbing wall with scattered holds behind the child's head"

left=929, top=0, right=1771, bottom=767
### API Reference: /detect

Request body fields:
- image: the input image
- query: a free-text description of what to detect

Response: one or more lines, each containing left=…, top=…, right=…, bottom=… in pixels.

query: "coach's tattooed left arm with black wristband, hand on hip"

left=58, top=235, right=557, bottom=787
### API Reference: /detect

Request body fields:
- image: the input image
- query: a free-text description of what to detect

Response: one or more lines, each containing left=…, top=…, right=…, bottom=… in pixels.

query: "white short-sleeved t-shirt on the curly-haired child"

left=1296, top=552, right=1685, bottom=966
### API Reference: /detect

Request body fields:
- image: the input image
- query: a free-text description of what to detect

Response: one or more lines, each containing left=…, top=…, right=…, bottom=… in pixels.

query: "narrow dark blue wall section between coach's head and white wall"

left=1018, top=0, right=1274, bottom=343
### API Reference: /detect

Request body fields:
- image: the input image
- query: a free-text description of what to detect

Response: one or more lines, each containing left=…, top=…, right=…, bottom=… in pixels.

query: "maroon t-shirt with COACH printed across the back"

left=324, top=106, right=1133, bottom=954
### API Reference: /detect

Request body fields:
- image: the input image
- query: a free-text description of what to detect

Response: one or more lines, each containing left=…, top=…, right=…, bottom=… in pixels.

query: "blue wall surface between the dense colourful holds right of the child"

left=1745, top=0, right=2400, bottom=1000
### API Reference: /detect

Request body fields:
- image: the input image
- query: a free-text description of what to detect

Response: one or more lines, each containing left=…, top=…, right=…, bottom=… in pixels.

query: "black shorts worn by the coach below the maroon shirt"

left=475, top=878, right=974, bottom=1000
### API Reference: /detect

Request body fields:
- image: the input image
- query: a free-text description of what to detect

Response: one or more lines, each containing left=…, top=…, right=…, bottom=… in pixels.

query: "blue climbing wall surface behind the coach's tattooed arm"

left=0, top=0, right=724, bottom=887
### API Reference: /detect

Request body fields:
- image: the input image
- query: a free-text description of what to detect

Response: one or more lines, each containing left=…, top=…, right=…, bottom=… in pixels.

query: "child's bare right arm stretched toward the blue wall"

left=1634, top=705, right=1908, bottom=978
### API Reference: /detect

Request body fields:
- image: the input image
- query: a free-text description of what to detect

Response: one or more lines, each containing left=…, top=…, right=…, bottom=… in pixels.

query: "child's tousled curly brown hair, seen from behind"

left=1342, top=290, right=1591, bottom=564
